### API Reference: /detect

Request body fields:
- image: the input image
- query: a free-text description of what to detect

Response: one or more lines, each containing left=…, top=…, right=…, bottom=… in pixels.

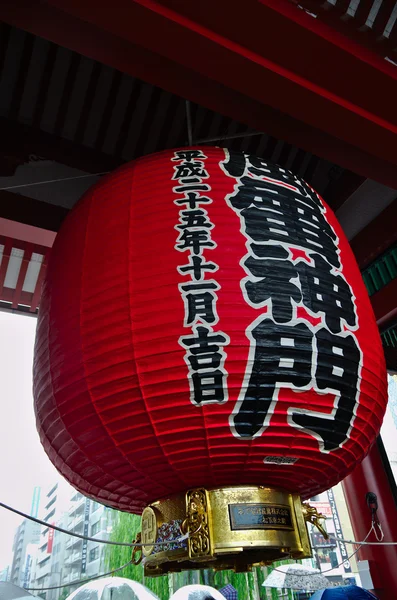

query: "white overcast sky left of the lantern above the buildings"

left=0, top=312, right=60, bottom=570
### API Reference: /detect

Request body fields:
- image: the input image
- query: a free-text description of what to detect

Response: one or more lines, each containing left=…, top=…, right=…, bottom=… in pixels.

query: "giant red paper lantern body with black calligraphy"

left=34, top=148, right=386, bottom=512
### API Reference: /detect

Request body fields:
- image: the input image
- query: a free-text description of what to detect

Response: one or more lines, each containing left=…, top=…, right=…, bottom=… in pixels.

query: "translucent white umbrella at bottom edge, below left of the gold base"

left=66, top=577, right=159, bottom=600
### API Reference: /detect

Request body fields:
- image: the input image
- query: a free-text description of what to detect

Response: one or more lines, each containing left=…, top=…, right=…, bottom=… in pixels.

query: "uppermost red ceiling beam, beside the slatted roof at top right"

left=154, top=0, right=397, bottom=123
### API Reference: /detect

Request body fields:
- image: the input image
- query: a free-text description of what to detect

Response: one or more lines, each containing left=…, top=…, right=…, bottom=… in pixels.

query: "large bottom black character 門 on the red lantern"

left=232, top=318, right=361, bottom=451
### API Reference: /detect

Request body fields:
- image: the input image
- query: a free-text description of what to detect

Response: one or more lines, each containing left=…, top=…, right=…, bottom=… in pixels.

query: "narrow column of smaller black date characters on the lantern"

left=171, top=149, right=230, bottom=406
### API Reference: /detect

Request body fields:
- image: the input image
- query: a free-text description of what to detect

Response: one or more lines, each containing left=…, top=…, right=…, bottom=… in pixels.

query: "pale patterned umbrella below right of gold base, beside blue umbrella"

left=262, top=564, right=331, bottom=592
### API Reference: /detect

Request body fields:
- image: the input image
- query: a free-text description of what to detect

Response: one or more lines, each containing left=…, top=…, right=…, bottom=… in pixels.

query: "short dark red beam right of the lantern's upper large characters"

left=350, top=200, right=397, bottom=268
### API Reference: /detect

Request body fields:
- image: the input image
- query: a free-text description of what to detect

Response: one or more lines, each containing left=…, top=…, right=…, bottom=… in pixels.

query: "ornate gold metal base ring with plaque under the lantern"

left=134, top=486, right=327, bottom=576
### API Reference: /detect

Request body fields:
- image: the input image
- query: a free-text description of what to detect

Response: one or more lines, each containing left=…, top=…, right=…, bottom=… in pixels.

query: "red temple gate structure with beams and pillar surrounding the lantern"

left=0, top=0, right=397, bottom=600
